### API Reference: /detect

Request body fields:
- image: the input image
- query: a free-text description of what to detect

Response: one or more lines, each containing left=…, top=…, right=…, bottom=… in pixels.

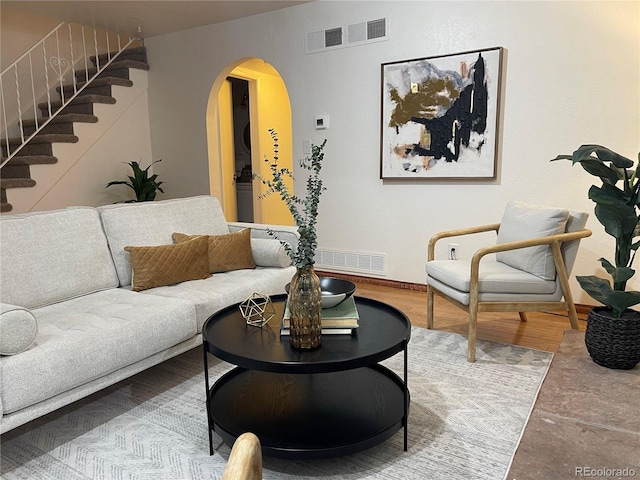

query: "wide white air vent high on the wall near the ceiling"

left=306, top=18, right=388, bottom=53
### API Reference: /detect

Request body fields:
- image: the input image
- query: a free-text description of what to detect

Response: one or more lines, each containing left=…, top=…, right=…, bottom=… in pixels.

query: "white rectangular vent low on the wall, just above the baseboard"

left=314, top=248, right=387, bottom=276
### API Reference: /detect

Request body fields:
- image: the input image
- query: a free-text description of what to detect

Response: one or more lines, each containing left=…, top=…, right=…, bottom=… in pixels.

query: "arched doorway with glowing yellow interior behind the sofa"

left=206, top=58, right=293, bottom=225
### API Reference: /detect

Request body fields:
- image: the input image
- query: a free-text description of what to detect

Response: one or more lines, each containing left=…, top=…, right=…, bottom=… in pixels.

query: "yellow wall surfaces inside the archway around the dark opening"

left=207, top=58, right=294, bottom=225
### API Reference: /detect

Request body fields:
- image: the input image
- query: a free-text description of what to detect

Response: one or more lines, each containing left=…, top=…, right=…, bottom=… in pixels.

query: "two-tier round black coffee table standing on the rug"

left=202, top=295, right=411, bottom=458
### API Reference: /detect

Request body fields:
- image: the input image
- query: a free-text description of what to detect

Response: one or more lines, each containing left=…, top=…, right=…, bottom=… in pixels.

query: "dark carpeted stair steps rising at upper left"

left=0, top=46, right=149, bottom=212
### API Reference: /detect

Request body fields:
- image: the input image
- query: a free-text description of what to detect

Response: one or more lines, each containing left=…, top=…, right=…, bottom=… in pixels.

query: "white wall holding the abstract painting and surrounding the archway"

left=146, top=1, right=640, bottom=303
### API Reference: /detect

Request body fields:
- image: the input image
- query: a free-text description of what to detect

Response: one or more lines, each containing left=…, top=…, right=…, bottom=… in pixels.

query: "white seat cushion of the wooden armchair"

left=427, top=258, right=556, bottom=295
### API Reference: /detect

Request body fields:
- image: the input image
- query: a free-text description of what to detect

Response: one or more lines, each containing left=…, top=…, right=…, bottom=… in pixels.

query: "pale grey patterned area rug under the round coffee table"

left=0, top=327, right=552, bottom=480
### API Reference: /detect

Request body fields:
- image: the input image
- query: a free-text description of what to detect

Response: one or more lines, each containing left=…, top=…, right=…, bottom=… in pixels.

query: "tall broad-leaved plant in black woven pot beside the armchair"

left=552, top=145, right=640, bottom=369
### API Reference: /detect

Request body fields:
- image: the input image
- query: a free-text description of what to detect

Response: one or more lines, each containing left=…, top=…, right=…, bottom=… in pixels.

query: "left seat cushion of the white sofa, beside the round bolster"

left=0, top=282, right=200, bottom=413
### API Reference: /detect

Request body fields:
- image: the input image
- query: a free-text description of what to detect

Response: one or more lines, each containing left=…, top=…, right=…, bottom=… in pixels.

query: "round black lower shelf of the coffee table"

left=207, top=365, right=409, bottom=458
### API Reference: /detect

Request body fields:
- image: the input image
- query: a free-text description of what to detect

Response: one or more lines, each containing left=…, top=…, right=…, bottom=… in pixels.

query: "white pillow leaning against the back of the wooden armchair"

left=496, top=201, right=569, bottom=280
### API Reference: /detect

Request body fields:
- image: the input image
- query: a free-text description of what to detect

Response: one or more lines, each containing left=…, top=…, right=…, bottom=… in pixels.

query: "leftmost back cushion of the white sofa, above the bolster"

left=0, top=207, right=119, bottom=309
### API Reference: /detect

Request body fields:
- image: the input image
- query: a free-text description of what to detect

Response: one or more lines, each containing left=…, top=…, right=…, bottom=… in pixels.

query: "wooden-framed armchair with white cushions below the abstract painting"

left=427, top=201, right=591, bottom=362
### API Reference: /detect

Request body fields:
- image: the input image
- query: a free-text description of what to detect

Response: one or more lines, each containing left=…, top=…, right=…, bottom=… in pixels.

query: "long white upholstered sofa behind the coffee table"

left=0, top=196, right=298, bottom=433
